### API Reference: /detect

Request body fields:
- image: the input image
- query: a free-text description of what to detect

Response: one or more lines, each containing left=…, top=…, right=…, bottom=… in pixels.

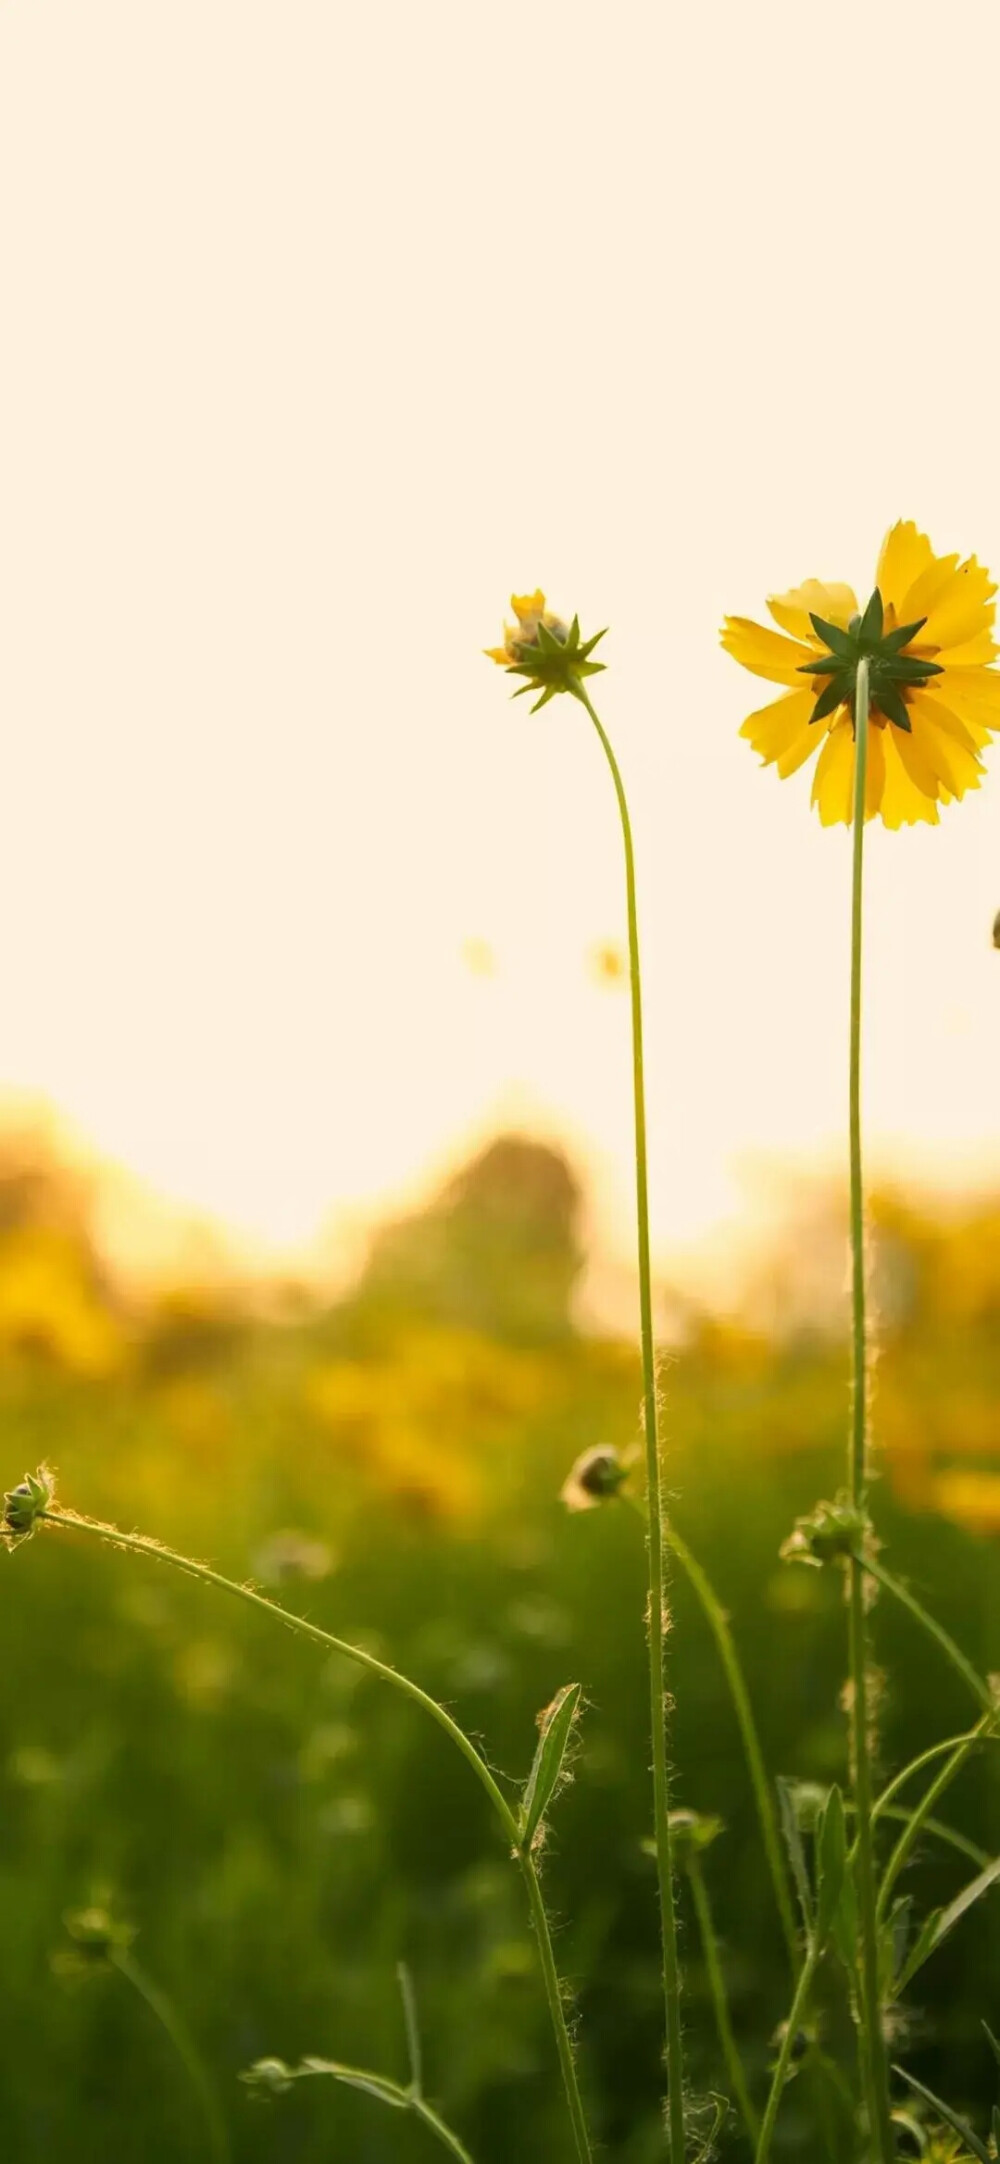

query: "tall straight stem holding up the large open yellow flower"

left=848, top=656, right=896, bottom=2164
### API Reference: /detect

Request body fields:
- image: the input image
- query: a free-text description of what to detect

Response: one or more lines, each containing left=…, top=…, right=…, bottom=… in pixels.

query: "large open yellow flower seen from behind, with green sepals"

left=723, top=519, right=1000, bottom=827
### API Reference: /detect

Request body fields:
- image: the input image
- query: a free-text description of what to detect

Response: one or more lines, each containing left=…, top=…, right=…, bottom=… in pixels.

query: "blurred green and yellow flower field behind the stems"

left=0, top=1143, right=1000, bottom=2164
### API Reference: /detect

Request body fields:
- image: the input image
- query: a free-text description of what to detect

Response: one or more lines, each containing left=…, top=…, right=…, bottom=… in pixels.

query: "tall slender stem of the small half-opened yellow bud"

left=578, top=684, right=684, bottom=2164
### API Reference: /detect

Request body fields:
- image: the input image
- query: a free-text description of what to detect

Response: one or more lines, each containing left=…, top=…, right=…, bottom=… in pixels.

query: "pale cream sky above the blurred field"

left=0, top=0, right=1000, bottom=1298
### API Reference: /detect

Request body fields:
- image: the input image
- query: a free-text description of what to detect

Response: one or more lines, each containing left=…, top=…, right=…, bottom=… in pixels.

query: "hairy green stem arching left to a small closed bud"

left=41, top=1504, right=591, bottom=2164
